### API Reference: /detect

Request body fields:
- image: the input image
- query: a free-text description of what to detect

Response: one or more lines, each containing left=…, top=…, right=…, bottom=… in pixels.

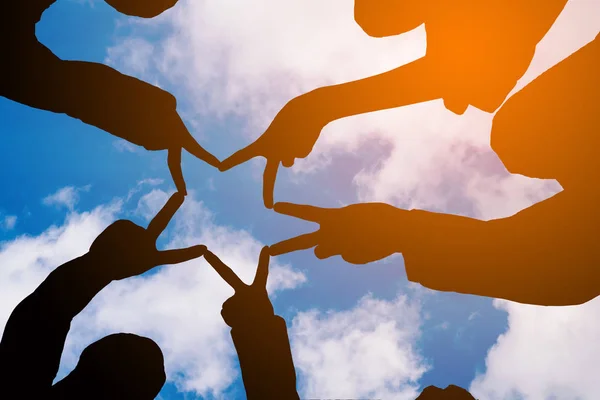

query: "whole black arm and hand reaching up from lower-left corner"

left=0, top=193, right=206, bottom=398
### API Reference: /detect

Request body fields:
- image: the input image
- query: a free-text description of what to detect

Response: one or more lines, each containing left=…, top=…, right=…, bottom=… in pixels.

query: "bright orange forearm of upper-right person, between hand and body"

left=303, top=57, right=441, bottom=125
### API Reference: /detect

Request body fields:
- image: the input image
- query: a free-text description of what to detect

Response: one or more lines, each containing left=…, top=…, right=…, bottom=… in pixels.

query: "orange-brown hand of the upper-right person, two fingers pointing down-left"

left=219, top=93, right=329, bottom=208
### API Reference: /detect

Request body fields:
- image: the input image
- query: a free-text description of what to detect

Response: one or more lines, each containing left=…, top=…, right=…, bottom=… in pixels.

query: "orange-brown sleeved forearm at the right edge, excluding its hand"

left=399, top=192, right=600, bottom=305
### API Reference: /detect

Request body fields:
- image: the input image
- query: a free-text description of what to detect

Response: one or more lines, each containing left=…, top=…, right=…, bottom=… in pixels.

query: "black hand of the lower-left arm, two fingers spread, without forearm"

left=89, top=192, right=206, bottom=280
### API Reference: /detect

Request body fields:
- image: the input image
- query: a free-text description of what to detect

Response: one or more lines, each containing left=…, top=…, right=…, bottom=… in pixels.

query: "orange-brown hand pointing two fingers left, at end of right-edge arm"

left=270, top=203, right=410, bottom=264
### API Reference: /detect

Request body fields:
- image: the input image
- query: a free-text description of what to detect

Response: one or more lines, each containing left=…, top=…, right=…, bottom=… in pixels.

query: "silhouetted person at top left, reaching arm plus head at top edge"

left=0, top=0, right=220, bottom=195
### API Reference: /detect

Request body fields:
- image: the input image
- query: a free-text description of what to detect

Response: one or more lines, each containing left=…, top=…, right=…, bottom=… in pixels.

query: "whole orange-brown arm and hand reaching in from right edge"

left=270, top=189, right=600, bottom=306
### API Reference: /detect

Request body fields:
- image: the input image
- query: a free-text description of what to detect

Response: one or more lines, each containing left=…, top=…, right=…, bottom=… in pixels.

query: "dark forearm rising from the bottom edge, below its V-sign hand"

left=231, top=315, right=299, bottom=400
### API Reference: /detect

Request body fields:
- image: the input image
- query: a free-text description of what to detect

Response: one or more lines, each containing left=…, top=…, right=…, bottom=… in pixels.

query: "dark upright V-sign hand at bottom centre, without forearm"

left=204, top=247, right=275, bottom=328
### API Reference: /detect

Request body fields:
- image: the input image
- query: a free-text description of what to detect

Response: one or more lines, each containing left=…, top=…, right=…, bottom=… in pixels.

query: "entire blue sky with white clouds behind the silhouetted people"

left=0, top=0, right=600, bottom=400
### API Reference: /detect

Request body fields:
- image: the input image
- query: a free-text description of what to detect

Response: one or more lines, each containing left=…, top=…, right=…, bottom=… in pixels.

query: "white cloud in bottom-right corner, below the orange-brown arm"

left=470, top=298, right=600, bottom=400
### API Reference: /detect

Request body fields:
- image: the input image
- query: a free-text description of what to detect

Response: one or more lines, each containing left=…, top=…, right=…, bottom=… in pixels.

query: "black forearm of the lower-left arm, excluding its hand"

left=0, top=253, right=111, bottom=395
